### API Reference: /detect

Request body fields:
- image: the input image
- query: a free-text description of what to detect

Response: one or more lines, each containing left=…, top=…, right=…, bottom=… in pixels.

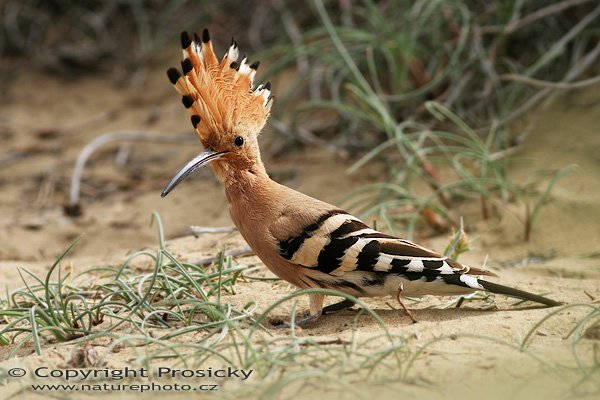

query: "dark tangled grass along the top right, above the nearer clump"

left=267, top=0, right=600, bottom=139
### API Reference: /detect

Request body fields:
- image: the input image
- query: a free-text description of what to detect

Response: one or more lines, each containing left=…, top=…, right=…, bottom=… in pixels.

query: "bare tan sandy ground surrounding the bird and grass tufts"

left=0, top=66, right=600, bottom=399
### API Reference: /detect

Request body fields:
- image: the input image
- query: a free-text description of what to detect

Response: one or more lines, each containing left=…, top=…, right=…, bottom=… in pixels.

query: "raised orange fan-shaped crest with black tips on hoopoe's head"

left=167, top=29, right=272, bottom=145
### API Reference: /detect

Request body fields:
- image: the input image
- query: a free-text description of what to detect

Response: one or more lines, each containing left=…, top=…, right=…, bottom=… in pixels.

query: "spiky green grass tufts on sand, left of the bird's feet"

left=0, top=214, right=255, bottom=356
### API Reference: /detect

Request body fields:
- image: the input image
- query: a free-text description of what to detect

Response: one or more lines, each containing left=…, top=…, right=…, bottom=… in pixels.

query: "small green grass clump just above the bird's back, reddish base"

left=344, top=102, right=574, bottom=241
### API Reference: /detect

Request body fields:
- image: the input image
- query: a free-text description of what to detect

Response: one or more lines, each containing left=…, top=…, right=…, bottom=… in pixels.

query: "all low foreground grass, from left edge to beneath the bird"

left=0, top=214, right=406, bottom=397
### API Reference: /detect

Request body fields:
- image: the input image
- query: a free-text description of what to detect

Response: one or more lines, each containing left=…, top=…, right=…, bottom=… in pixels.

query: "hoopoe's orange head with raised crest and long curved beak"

left=162, top=29, right=272, bottom=197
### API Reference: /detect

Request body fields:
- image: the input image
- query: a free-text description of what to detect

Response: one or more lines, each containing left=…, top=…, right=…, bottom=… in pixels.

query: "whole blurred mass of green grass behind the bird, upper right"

left=270, top=0, right=600, bottom=241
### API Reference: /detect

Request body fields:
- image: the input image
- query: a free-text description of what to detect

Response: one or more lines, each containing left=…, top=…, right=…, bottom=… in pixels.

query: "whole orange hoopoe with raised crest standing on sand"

left=162, top=29, right=560, bottom=325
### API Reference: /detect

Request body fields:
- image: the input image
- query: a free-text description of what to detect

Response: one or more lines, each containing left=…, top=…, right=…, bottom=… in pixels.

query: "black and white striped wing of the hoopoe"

left=279, top=210, right=487, bottom=288
